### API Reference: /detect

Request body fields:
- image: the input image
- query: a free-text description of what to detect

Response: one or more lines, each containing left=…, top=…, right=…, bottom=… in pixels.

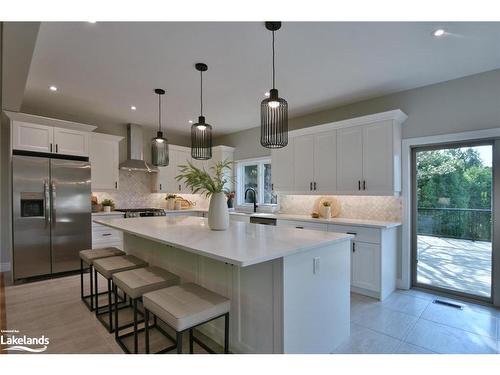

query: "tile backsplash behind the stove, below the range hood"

left=92, top=170, right=208, bottom=209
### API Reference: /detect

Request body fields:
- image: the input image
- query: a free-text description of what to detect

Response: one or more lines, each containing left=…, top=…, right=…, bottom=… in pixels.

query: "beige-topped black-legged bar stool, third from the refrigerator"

left=113, top=267, right=180, bottom=354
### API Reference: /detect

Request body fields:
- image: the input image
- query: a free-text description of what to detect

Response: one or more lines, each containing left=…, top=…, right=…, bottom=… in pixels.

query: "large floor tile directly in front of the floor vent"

left=421, top=303, right=497, bottom=339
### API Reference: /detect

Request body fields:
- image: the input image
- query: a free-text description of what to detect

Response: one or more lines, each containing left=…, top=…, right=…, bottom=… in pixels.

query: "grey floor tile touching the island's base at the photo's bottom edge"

left=334, top=324, right=401, bottom=354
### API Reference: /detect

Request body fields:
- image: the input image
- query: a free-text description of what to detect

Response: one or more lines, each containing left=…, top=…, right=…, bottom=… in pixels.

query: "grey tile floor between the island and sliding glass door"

left=335, top=290, right=500, bottom=354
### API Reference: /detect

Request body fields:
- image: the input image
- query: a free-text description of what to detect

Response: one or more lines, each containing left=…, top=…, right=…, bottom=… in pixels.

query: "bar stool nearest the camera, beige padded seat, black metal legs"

left=142, top=283, right=230, bottom=354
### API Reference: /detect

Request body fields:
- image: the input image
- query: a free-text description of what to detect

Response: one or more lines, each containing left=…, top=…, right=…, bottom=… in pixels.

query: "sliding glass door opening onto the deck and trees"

left=412, top=142, right=493, bottom=300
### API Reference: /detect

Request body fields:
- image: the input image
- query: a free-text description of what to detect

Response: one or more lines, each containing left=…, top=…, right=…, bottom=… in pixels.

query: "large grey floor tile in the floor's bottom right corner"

left=405, top=319, right=497, bottom=354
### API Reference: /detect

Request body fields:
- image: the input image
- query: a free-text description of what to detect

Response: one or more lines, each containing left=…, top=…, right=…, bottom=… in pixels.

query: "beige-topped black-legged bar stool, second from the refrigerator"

left=94, top=255, right=148, bottom=333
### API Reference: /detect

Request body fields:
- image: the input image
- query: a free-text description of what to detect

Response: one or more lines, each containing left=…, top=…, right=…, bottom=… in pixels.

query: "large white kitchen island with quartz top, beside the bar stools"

left=94, top=216, right=352, bottom=353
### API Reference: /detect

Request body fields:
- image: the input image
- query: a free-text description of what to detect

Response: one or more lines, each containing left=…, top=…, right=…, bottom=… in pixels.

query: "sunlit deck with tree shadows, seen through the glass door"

left=417, top=235, right=491, bottom=297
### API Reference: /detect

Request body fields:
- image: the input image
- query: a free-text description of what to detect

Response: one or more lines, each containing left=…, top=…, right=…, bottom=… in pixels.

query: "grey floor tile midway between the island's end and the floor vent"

left=351, top=305, right=418, bottom=340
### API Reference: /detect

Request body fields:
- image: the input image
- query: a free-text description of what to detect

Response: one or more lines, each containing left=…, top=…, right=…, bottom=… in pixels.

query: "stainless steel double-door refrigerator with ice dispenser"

left=12, top=155, right=92, bottom=280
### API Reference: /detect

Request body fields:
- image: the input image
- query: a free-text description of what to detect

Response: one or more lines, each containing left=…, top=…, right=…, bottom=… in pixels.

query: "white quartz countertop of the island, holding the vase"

left=94, top=216, right=353, bottom=267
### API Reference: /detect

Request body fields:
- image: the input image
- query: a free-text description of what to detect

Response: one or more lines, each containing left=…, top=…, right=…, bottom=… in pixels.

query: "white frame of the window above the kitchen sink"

left=235, top=157, right=277, bottom=207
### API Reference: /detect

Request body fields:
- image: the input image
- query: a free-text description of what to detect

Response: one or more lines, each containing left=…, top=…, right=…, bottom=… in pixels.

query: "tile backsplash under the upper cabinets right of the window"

left=278, top=194, right=402, bottom=221
